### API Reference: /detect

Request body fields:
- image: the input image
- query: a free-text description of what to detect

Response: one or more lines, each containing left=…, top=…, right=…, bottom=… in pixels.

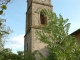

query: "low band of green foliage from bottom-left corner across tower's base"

left=0, top=48, right=41, bottom=60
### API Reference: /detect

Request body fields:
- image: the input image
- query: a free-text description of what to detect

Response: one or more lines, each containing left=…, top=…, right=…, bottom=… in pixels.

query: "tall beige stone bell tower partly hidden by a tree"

left=24, top=0, right=52, bottom=56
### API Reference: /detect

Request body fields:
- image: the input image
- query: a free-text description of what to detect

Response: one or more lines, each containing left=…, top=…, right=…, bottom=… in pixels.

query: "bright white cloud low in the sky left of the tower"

left=5, top=34, right=24, bottom=51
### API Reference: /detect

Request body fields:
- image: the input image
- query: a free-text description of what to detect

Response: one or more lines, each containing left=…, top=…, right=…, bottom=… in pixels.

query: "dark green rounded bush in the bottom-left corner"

left=0, top=48, right=18, bottom=60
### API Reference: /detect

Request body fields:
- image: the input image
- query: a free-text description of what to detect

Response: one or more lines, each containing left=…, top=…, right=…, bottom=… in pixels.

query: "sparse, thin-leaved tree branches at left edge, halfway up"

left=0, top=19, right=11, bottom=50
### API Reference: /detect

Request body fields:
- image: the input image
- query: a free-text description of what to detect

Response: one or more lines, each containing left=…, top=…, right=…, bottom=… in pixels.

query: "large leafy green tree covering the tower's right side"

left=36, top=9, right=80, bottom=60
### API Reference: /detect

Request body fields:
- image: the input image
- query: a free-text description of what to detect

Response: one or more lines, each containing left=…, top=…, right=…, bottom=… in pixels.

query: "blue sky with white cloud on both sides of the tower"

left=0, top=0, right=80, bottom=52
